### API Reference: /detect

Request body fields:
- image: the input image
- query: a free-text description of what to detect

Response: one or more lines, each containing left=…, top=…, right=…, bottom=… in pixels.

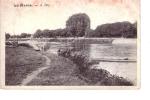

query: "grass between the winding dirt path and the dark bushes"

left=28, top=52, right=87, bottom=86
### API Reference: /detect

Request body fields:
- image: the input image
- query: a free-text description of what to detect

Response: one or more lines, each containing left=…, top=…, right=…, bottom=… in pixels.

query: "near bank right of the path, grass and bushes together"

left=28, top=48, right=133, bottom=86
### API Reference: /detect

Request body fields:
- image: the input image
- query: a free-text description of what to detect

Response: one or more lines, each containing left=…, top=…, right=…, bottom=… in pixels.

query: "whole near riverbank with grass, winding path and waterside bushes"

left=6, top=46, right=132, bottom=86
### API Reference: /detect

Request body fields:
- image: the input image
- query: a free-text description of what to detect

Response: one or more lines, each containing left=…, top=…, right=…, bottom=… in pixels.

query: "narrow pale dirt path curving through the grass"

left=21, top=55, right=51, bottom=85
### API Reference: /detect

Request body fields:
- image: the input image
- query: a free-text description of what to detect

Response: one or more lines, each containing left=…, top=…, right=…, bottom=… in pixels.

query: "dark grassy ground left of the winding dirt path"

left=5, top=46, right=45, bottom=85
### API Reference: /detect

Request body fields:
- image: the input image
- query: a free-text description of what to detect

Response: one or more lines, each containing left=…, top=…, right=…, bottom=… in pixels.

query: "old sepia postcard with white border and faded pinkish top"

left=0, top=0, right=140, bottom=89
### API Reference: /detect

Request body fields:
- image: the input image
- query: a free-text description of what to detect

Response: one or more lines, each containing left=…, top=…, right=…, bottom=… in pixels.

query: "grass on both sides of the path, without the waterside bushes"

left=5, top=46, right=86, bottom=86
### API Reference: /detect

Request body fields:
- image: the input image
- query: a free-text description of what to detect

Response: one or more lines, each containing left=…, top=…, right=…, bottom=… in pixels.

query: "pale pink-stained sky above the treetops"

left=0, top=0, right=139, bottom=35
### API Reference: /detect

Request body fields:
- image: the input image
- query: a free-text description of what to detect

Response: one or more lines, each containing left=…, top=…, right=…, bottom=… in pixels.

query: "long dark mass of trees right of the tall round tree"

left=87, top=22, right=137, bottom=38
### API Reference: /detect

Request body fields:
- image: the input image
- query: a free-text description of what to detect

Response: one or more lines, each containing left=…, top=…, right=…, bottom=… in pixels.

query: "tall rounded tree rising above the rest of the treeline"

left=66, top=13, right=90, bottom=37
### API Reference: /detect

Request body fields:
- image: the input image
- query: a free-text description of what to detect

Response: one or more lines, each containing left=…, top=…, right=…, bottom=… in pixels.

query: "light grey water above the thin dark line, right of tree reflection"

left=90, top=44, right=137, bottom=60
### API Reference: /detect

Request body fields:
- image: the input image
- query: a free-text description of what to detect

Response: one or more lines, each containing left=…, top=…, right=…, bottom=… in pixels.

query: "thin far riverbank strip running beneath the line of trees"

left=8, top=37, right=137, bottom=44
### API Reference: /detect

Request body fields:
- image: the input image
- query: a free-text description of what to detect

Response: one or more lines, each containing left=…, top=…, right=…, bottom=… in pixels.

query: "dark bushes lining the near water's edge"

left=58, top=49, right=133, bottom=86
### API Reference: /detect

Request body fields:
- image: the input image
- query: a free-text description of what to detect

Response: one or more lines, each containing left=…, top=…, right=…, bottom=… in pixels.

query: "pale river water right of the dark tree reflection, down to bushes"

left=90, top=44, right=137, bottom=84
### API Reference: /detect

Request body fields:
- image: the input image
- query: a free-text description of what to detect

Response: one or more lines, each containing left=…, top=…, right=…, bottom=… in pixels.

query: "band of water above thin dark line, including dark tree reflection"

left=48, top=42, right=137, bottom=61
